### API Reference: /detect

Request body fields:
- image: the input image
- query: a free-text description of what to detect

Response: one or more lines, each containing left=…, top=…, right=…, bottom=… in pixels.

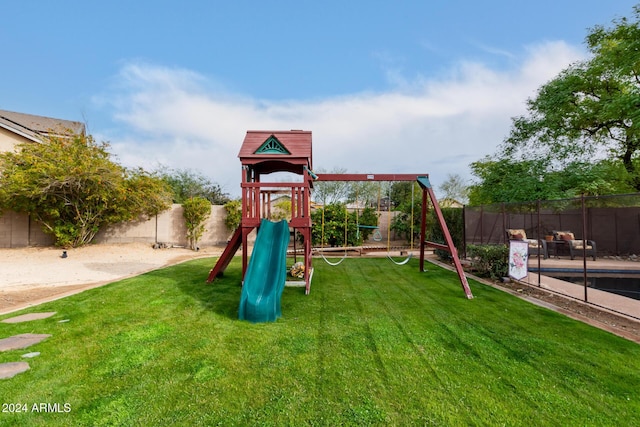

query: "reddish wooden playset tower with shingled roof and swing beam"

left=207, top=130, right=473, bottom=299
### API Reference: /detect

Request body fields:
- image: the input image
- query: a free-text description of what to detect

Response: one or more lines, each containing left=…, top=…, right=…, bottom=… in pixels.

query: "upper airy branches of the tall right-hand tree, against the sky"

left=499, top=6, right=640, bottom=191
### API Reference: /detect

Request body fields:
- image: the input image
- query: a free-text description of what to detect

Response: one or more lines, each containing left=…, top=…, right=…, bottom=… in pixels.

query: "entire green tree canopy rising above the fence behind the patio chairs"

left=471, top=5, right=640, bottom=202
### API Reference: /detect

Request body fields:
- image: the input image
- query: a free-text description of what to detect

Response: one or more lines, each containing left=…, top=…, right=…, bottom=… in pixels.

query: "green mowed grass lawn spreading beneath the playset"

left=0, top=259, right=640, bottom=426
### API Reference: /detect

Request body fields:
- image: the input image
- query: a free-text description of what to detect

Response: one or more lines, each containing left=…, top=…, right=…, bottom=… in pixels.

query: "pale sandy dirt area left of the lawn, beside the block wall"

left=0, top=243, right=222, bottom=314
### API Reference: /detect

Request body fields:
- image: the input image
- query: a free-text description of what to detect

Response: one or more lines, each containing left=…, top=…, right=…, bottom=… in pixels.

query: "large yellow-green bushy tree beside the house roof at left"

left=0, top=134, right=171, bottom=247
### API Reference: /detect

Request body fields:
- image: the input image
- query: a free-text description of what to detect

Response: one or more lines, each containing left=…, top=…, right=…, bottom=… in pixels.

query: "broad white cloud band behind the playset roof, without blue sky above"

left=96, top=42, right=581, bottom=195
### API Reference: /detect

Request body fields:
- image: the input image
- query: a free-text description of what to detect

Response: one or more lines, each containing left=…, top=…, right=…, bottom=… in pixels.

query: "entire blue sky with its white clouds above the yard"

left=0, top=0, right=637, bottom=194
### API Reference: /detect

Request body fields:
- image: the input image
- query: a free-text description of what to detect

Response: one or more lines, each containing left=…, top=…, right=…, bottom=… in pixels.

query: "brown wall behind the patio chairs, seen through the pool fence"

left=462, top=193, right=640, bottom=318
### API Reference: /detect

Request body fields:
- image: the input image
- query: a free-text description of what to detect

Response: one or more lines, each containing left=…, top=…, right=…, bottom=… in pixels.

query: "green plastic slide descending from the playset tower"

left=238, top=219, right=289, bottom=322
